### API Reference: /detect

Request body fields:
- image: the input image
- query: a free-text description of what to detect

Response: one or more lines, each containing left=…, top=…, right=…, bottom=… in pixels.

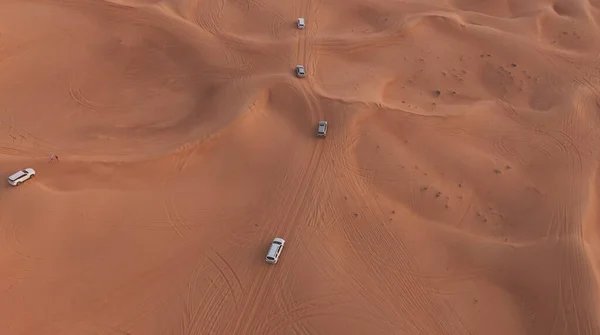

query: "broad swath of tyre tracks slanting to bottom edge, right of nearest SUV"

left=328, top=124, right=471, bottom=334
